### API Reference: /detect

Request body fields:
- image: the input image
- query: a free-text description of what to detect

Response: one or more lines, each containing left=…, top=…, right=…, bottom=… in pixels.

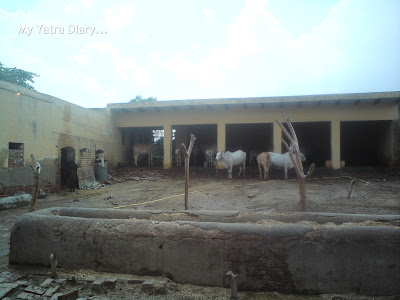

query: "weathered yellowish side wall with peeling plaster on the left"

left=0, top=81, right=118, bottom=194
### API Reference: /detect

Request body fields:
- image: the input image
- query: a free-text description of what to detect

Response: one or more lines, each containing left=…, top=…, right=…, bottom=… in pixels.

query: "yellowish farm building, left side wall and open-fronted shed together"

left=0, top=81, right=400, bottom=196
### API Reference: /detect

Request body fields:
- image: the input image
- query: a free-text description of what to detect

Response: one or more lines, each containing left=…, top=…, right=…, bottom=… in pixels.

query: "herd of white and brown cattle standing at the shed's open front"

left=132, top=144, right=306, bottom=179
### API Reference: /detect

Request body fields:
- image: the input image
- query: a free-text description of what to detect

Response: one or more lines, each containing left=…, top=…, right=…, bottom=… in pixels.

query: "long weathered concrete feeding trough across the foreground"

left=10, top=208, right=400, bottom=295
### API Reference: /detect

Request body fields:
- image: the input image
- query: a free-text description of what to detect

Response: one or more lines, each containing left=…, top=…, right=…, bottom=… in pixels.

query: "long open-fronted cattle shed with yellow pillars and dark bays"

left=108, top=92, right=400, bottom=169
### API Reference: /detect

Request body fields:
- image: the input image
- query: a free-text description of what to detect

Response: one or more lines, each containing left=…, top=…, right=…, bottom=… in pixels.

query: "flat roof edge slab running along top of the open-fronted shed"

left=107, top=91, right=400, bottom=111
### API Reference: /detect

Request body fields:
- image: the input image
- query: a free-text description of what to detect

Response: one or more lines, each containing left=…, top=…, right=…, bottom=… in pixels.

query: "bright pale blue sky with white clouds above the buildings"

left=0, top=0, right=400, bottom=108
